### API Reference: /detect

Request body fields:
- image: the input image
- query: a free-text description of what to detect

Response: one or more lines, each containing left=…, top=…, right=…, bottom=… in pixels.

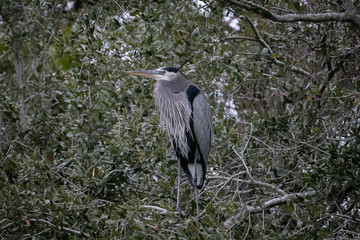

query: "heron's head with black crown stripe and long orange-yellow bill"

left=125, top=67, right=182, bottom=82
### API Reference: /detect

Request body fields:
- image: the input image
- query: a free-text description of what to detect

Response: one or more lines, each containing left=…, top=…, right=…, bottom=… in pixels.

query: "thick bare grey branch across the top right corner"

left=228, top=0, right=360, bottom=25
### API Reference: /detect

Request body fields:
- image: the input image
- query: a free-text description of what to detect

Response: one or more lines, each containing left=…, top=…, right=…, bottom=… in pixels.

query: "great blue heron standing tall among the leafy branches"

left=126, top=67, right=212, bottom=220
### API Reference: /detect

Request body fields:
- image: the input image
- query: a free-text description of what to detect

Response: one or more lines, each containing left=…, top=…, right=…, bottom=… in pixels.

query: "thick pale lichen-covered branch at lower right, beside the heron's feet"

left=224, top=191, right=316, bottom=228
